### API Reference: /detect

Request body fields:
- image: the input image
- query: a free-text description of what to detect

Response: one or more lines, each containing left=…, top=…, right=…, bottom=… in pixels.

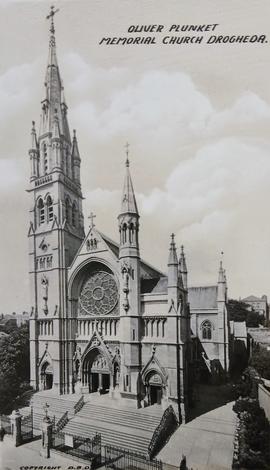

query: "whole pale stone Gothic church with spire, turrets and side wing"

left=28, top=14, right=228, bottom=420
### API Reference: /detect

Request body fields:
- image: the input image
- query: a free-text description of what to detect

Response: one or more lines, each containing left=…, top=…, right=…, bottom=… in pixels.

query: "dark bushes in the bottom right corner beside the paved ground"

left=233, top=398, right=270, bottom=470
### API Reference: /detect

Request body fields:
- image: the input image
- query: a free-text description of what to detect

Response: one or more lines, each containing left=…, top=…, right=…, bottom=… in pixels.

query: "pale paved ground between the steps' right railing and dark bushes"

left=157, top=403, right=236, bottom=470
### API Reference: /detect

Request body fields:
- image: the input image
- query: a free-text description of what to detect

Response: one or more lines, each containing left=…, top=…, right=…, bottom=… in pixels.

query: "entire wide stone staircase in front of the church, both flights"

left=32, top=391, right=177, bottom=457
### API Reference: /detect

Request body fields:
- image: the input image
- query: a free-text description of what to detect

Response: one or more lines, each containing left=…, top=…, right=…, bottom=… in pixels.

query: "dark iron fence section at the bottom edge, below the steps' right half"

left=104, top=446, right=162, bottom=470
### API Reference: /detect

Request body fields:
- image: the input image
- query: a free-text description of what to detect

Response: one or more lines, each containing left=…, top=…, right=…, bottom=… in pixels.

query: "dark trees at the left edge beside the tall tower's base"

left=0, top=324, right=30, bottom=414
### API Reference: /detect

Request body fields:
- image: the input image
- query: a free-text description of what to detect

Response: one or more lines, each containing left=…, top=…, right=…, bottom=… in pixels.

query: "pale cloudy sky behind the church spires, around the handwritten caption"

left=0, top=0, right=270, bottom=313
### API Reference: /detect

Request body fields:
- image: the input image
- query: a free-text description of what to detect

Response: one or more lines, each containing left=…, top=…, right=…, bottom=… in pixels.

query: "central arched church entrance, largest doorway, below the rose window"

left=82, top=349, right=111, bottom=393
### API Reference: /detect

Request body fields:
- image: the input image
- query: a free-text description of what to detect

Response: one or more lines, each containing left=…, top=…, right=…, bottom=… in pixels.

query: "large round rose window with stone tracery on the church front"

left=79, top=271, right=118, bottom=315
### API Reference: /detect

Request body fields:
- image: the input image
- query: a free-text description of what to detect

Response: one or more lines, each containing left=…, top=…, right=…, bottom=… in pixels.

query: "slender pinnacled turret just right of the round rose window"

left=118, top=150, right=141, bottom=397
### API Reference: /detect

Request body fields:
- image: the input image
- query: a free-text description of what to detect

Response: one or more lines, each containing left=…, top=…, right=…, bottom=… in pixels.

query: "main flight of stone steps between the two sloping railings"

left=63, top=400, right=163, bottom=455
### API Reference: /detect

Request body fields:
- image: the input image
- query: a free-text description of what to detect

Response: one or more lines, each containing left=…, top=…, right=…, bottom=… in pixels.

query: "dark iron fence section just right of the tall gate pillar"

left=52, top=431, right=101, bottom=464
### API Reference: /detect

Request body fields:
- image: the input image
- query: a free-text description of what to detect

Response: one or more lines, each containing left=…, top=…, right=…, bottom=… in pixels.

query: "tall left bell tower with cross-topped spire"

left=28, top=7, right=84, bottom=393
